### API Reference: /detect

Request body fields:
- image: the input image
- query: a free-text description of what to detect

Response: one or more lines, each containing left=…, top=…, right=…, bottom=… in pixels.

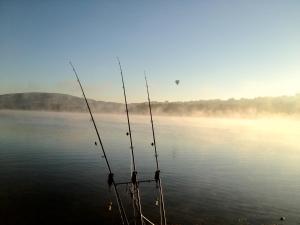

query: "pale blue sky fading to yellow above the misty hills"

left=0, top=0, right=300, bottom=102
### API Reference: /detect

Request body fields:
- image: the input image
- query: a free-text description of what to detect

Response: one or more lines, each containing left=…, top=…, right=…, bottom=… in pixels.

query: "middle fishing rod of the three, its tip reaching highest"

left=117, top=57, right=144, bottom=224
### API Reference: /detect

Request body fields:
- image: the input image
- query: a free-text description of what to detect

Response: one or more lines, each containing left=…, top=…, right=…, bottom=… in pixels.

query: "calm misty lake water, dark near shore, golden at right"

left=0, top=111, right=300, bottom=225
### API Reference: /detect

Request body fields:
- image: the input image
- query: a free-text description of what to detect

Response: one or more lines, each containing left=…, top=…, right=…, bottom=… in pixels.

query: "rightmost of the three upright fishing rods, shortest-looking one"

left=144, top=71, right=167, bottom=225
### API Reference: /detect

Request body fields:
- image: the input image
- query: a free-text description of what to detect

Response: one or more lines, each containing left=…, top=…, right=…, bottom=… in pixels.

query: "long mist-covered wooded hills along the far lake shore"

left=0, top=92, right=300, bottom=116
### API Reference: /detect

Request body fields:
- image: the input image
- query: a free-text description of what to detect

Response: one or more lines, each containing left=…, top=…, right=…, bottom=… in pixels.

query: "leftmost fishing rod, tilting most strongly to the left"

left=69, top=61, right=129, bottom=225
